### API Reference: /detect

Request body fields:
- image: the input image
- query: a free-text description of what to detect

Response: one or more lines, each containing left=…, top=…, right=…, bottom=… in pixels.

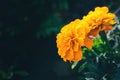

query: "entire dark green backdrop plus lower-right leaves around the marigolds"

left=0, top=0, right=120, bottom=80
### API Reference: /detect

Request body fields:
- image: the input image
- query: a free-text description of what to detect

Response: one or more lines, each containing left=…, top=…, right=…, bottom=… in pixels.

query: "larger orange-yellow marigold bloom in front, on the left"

left=56, top=19, right=89, bottom=62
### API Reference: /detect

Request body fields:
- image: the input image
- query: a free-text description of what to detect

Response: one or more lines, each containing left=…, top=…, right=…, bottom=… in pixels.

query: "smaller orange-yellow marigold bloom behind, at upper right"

left=83, top=7, right=116, bottom=49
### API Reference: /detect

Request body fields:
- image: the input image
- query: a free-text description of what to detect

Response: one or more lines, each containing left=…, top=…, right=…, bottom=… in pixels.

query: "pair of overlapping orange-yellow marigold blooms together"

left=56, top=7, right=116, bottom=62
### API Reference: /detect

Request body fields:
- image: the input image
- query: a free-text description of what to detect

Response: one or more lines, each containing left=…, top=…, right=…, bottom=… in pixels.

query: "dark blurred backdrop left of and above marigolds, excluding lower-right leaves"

left=0, top=0, right=119, bottom=80
